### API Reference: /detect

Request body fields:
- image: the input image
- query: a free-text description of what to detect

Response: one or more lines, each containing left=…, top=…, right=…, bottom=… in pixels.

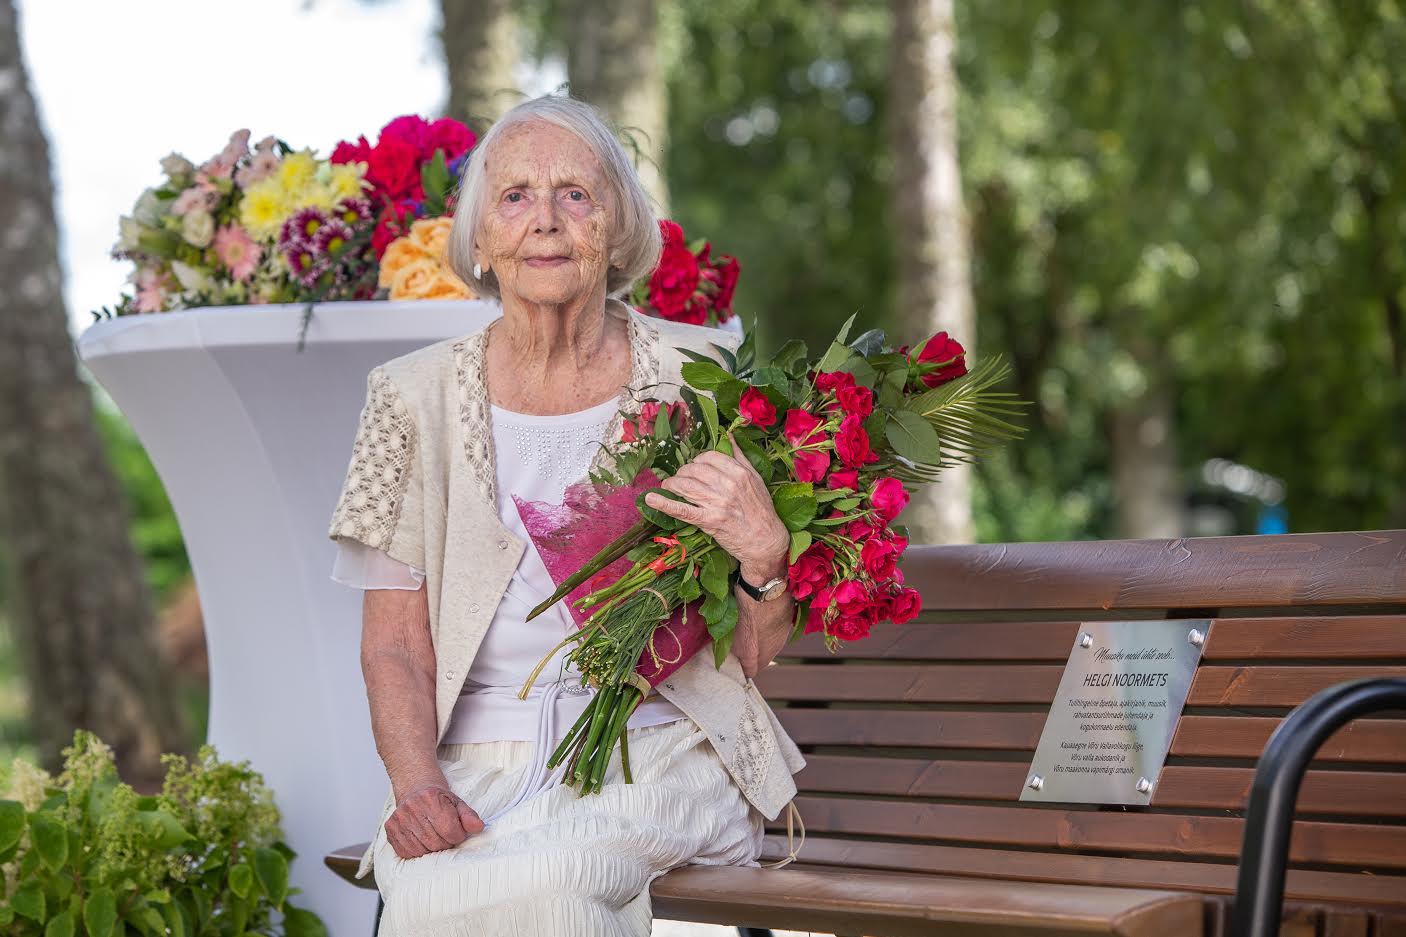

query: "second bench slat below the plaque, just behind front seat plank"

left=762, top=836, right=1406, bottom=909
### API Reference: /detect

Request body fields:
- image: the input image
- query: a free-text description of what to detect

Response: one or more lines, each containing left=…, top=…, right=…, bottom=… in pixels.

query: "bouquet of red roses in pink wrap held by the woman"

left=517, top=318, right=1024, bottom=793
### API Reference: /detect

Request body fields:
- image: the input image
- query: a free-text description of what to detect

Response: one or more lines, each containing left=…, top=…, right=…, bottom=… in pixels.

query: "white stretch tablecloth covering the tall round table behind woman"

left=76, top=301, right=738, bottom=937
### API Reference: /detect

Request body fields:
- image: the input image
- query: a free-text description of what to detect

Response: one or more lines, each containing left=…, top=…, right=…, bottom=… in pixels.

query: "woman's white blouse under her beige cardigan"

left=332, top=398, right=685, bottom=753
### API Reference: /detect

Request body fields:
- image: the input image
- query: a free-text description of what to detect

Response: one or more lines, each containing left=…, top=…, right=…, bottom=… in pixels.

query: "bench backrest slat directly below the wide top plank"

left=780, top=615, right=1406, bottom=664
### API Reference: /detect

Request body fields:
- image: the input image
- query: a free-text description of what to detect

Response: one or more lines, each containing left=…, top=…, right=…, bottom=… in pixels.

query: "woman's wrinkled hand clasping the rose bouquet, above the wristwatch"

left=644, top=433, right=790, bottom=582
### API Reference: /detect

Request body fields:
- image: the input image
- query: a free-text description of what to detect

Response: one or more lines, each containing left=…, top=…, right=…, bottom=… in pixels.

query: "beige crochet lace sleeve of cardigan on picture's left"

left=328, top=367, right=425, bottom=570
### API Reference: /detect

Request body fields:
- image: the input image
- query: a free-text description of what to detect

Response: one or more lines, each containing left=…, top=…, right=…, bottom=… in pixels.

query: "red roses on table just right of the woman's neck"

left=630, top=221, right=741, bottom=325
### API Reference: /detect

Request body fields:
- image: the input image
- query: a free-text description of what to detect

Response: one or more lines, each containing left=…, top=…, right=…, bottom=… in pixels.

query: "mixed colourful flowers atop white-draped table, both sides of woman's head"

left=93, top=122, right=740, bottom=325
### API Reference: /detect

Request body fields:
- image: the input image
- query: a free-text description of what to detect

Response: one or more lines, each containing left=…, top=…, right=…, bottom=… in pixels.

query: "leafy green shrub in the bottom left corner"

left=0, top=732, right=326, bottom=937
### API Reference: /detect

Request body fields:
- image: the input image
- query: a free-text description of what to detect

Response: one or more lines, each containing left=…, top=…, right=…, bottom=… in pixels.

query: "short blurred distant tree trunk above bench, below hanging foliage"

left=1111, top=369, right=1182, bottom=540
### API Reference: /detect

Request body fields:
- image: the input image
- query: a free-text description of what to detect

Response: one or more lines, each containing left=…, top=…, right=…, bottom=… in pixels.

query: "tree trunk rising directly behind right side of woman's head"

left=567, top=0, right=669, bottom=215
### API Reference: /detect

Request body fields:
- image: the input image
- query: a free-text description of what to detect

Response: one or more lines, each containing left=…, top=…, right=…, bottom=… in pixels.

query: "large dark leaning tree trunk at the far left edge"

left=0, top=0, right=187, bottom=786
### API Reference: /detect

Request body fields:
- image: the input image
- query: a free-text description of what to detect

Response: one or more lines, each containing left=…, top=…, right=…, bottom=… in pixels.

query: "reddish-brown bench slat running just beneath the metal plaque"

left=796, top=795, right=1406, bottom=869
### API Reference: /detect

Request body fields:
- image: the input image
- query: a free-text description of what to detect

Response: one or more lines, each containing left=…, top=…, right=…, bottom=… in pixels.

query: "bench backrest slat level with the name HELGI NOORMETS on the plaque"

left=756, top=664, right=1406, bottom=708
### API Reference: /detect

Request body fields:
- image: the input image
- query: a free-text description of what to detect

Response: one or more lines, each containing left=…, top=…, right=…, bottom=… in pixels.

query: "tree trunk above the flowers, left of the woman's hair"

left=440, top=0, right=522, bottom=134
